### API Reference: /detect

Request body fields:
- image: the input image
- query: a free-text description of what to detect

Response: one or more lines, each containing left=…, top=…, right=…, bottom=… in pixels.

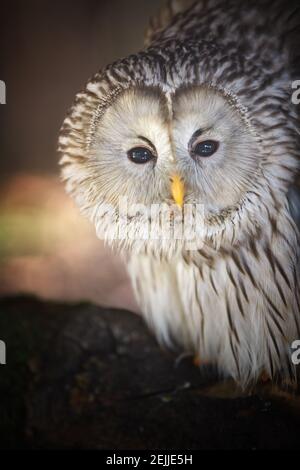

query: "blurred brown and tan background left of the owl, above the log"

left=0, top=0, right=161, bottom=310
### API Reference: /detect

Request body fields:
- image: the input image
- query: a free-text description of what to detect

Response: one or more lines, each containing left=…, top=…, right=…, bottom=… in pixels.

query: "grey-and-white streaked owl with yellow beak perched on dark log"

left=58, top=0, right=300, bottom=387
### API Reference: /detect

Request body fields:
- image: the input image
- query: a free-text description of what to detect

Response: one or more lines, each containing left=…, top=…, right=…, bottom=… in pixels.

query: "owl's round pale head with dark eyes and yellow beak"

left=59, top=43, right=298, bottom=254
